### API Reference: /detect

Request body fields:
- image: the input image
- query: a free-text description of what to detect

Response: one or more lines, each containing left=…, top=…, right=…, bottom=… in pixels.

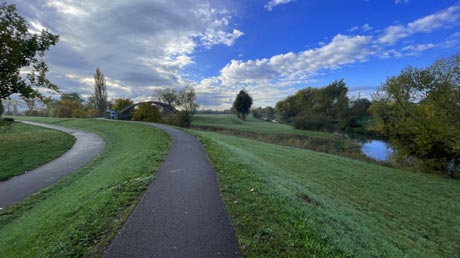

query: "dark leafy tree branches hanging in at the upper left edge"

left=0, top=2, right=59, bottom=100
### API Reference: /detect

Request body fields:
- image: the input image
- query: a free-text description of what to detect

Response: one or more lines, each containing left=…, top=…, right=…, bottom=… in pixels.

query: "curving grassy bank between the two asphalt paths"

left=0, top=118, right=169, bottom=257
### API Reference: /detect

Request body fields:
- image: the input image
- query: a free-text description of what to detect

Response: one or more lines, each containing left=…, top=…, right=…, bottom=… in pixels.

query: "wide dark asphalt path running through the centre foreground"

left=103, top=123, right=241, bottom=258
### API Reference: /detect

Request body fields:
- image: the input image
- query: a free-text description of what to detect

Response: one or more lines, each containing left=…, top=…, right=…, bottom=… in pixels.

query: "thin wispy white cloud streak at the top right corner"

left=378, top=5, right=460, bottom=45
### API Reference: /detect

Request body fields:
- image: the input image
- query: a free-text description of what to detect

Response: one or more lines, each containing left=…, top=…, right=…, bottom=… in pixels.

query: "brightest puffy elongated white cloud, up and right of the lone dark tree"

left=220, top=34, right=371, bottom=86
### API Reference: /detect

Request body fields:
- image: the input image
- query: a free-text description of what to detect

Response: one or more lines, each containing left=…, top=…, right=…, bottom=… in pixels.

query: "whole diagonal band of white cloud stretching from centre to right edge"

left=198, top=6, right=460, bottom=106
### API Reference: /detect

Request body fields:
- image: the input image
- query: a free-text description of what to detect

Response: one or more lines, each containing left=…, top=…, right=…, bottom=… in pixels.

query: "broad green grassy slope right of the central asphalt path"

left=195, top=132, right=460, bottom=257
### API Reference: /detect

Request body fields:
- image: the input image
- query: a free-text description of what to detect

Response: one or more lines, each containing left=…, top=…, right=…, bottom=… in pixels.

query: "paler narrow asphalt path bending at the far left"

left=0, top=121, right=105, bottom=210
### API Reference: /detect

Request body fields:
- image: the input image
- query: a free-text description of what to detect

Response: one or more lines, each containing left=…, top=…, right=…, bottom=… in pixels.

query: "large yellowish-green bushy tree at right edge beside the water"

left=370, top=54, right=460, bottom=176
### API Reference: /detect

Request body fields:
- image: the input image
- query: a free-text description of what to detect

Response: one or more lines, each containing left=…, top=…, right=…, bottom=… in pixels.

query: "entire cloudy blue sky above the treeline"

left=8, top=0, right=460, bottom=110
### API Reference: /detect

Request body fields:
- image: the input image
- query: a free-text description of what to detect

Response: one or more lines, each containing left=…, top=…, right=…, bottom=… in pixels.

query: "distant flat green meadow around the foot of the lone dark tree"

left=192, top=114, right=335, bottom=138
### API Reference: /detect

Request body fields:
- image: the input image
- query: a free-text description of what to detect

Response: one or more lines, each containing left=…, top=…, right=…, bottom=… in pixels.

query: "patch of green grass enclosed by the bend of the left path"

left=0, top=123, right=75, bottom=181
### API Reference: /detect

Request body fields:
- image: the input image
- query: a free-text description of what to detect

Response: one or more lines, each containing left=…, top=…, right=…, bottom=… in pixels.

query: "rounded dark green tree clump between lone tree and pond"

left=275, top=80, right=349, bottom=131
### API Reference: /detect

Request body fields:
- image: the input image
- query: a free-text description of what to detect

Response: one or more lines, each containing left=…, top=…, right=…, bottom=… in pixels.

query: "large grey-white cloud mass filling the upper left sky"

left=13, top=0, right=244, bottom=98
